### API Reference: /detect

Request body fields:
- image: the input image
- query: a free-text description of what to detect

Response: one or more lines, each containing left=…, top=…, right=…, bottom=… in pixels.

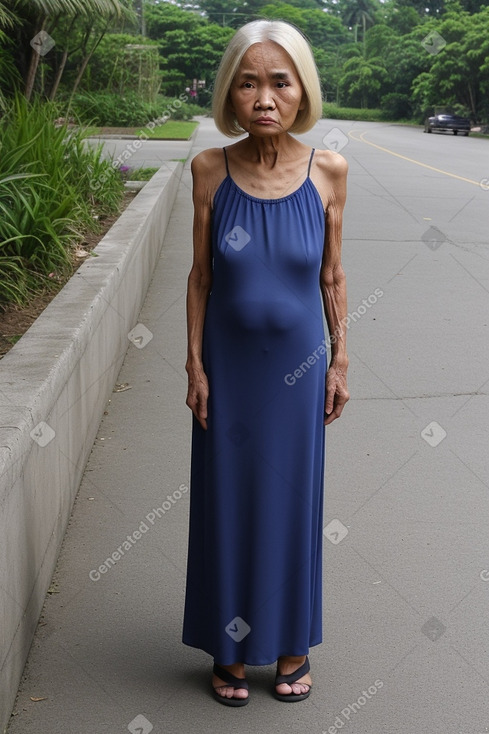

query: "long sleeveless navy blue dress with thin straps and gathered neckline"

left=183, top=149, right=327, bottom=665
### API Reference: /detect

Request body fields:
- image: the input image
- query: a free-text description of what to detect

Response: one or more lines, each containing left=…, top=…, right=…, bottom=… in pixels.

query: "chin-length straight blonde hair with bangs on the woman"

left=212, top=20, right=322, bottom=137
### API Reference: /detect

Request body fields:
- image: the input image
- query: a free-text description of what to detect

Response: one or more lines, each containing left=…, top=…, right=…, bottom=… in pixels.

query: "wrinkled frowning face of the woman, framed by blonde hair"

left=229, top=41, right=305, bottom=137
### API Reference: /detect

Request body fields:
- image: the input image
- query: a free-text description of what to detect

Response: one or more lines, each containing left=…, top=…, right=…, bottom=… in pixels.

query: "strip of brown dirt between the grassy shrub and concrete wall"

left=0, top=191, right=138, bottom=359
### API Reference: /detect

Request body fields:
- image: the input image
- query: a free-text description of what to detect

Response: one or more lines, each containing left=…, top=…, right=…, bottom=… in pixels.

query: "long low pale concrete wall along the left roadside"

left=0, top=163, right=183, bottom=731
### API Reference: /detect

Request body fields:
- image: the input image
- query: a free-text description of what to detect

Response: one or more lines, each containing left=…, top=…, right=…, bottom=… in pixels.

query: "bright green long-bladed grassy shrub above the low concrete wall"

left=0, top=95, right=124, bottom=303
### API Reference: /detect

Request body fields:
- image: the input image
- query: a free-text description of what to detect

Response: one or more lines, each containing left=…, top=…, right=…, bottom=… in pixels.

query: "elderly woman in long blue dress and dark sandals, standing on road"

left=183, top=20, right=349, bottom=706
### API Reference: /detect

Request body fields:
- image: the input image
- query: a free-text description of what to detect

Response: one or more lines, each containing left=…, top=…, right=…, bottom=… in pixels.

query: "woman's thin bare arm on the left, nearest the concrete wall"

left=185, top=151, right=212, bottom=429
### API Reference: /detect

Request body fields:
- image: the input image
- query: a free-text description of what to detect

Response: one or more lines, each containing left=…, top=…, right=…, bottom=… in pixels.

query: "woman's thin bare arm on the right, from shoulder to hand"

left=320, top=151, right=350, bottom=426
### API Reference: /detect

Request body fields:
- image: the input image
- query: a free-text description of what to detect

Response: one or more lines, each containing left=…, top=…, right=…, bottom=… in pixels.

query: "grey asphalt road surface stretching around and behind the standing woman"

left=9, top=120, right=489, bottom=734
